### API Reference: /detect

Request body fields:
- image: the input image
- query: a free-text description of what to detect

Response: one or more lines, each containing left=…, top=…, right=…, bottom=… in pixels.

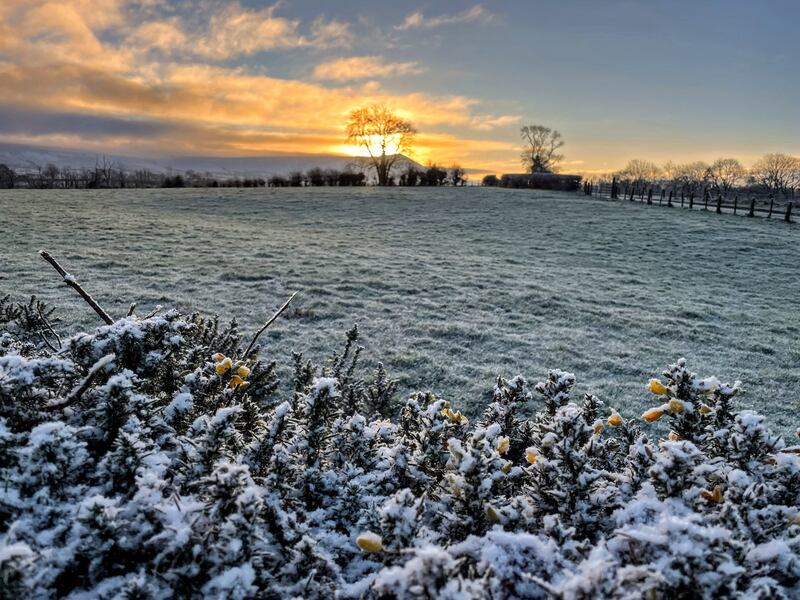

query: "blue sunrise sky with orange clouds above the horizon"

left=0, top=0, right=800, bottom=173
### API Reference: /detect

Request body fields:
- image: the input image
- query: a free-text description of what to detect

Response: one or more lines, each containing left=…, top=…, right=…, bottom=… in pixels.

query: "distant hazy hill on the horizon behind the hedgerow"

left=0, top=143, right=423, bottom=179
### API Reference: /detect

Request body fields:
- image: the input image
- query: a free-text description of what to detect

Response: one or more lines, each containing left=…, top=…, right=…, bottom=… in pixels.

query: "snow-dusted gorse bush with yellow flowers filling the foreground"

left=0, top=292, right=800, bottom=599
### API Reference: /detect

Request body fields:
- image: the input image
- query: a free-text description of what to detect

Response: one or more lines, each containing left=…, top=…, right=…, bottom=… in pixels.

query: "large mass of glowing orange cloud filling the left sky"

left=0, top=0, right=516, bottom=173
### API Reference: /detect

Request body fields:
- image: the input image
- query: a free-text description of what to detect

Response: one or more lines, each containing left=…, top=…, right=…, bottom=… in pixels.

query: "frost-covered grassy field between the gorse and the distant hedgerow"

left=0, top=189, right=800, bottom=431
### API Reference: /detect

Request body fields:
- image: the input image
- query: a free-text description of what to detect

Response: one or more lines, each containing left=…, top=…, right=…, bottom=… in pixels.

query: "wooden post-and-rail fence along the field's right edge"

left=583, top=179, right=794, bottom=223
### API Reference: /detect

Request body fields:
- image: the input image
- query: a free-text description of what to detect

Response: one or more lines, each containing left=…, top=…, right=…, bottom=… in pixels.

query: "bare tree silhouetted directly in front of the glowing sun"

left=347, top=104, right=417, bottom=185
